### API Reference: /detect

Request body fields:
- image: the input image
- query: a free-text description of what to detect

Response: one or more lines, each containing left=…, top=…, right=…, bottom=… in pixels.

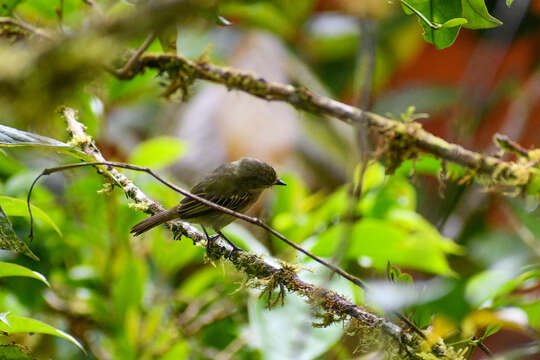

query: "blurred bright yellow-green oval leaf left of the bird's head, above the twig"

left=129, top=136, right=186, bottom=169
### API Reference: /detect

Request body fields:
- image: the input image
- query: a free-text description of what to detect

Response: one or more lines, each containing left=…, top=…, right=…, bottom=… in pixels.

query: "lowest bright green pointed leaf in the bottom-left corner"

left=0, top=312, right=86, bottom=353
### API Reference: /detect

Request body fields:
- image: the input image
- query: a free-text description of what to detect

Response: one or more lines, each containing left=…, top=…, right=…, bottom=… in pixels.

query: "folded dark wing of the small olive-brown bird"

left=178, top=192, right=253, bottom=219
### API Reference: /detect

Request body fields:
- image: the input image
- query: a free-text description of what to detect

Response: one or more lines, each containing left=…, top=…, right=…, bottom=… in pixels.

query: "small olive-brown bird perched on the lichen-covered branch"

left=131, top=158, right=286, bottom=249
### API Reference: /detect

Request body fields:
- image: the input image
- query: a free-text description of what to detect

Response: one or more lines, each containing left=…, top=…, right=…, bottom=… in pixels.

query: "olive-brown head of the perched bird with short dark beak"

left=232, top=158, right=286, bottom=190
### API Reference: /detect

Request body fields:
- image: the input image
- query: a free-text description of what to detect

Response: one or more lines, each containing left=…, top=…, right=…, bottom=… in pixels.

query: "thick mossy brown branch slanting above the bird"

left=125, top=53, right=540, bottom=194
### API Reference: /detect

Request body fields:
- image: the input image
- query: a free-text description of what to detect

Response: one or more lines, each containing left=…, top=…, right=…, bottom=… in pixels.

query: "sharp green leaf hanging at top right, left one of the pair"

left=401, top=0, right=462, bottom=49
